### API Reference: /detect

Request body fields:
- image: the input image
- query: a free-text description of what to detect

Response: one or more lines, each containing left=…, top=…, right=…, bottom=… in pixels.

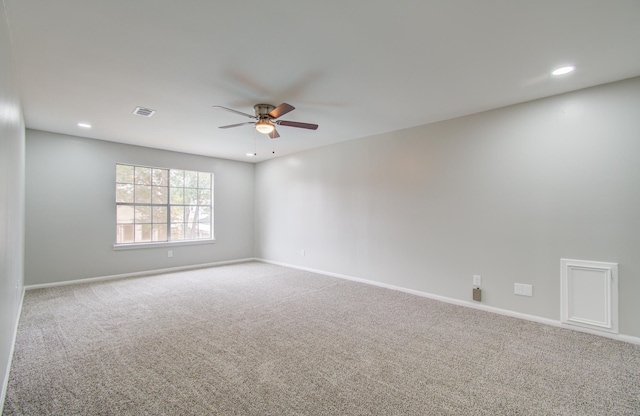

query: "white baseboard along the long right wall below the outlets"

left=254, top=258, right=640, bottom=345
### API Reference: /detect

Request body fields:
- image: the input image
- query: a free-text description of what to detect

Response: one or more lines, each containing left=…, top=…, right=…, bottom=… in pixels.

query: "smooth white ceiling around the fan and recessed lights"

left=3, top=0, right=640, bottom=162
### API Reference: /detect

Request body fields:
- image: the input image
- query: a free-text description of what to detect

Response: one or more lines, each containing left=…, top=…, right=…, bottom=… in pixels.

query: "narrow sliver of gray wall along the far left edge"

left=0, top=3, right=25, bottom=406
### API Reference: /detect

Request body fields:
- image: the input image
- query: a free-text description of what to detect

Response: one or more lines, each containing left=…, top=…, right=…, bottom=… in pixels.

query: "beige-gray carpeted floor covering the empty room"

left=3, top=263, right=640, bottom=416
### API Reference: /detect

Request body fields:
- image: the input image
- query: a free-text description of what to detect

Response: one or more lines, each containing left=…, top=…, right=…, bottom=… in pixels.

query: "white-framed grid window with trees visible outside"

left=116, top=164, right=213, bottom=244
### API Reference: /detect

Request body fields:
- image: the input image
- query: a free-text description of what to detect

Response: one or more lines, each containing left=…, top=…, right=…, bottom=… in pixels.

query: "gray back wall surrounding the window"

left=25, top=129, right=254, bottom=284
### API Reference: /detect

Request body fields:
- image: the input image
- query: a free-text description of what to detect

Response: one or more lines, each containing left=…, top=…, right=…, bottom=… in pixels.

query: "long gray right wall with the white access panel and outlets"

left=255, top=78, right=640, bottom=337
